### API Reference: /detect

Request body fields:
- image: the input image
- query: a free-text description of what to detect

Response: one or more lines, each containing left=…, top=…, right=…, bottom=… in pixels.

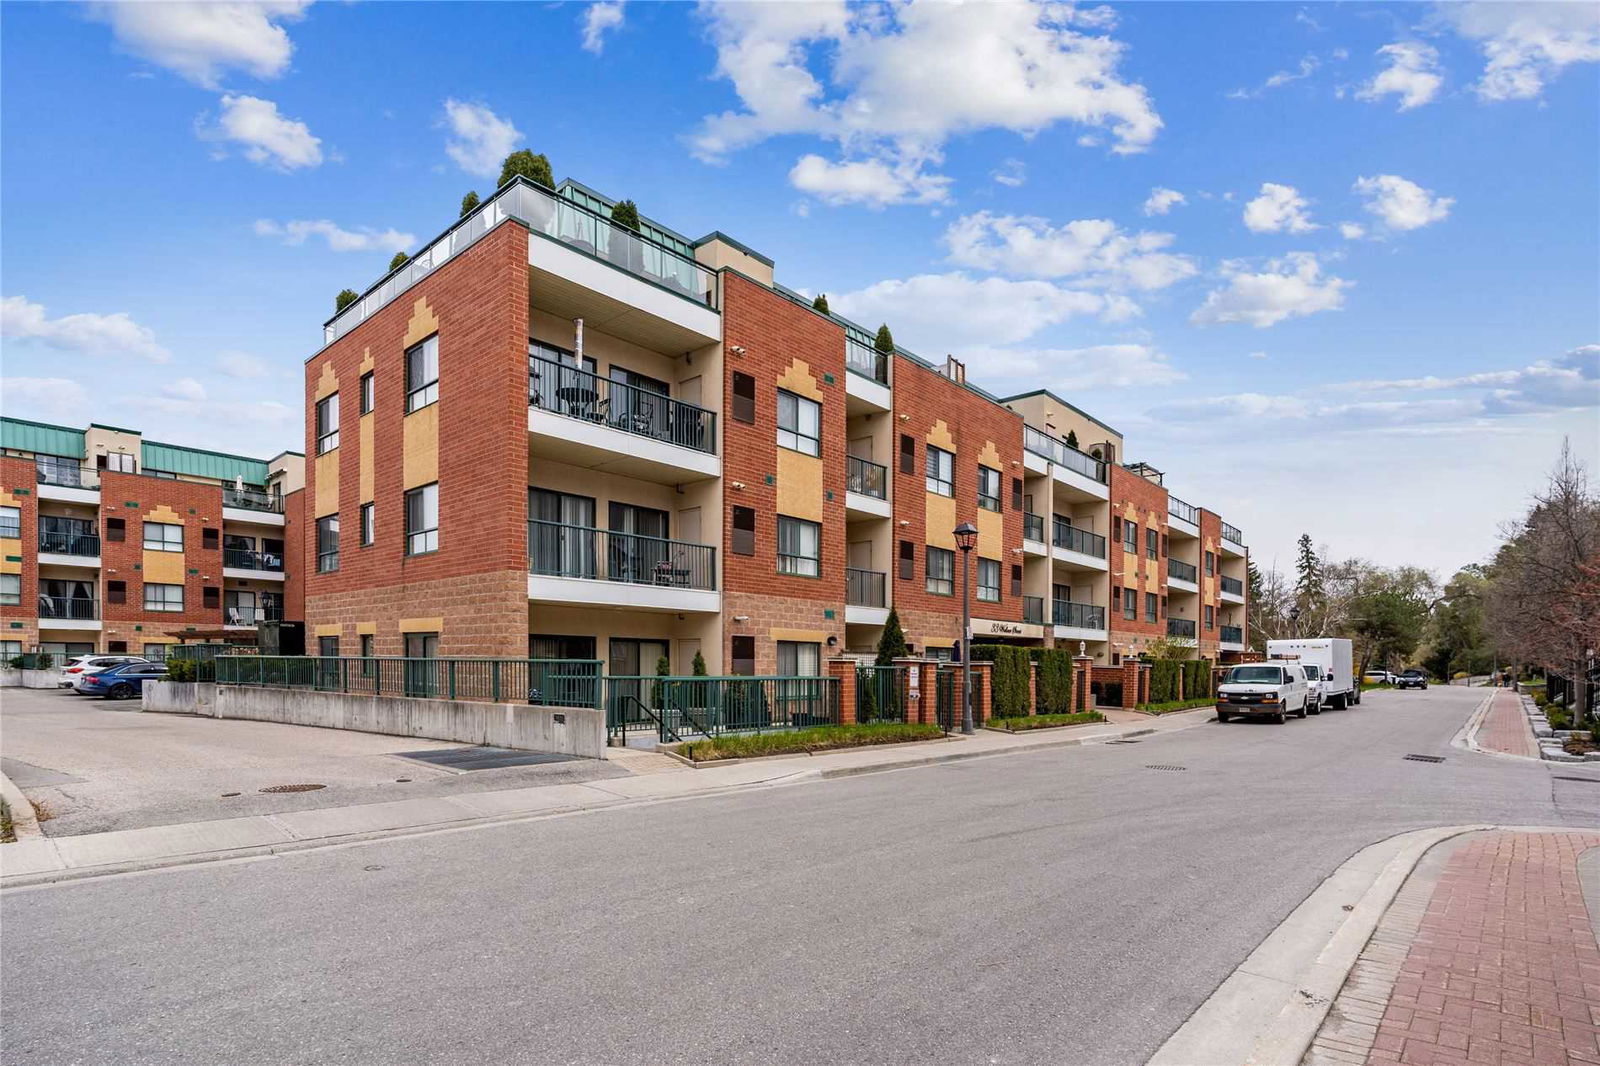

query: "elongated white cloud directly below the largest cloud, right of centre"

left=944, top=211, right=1197, bottom=291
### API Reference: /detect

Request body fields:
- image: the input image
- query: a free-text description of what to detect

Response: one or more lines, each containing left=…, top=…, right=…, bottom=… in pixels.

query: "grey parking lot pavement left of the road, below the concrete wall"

left=0, top=688, right=629, bottom=837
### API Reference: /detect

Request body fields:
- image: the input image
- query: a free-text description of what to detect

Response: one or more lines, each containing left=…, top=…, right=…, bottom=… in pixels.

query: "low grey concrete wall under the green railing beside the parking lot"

left=214, top=685, right=605, bottom=759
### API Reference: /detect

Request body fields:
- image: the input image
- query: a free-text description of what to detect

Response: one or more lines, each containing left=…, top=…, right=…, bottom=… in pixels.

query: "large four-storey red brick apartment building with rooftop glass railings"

left=302, top=179, right=1246, bottom=675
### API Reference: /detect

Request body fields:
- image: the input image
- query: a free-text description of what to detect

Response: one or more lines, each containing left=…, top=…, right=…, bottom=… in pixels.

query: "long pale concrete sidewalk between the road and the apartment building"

left=0, top=707, right=1213, bottom=888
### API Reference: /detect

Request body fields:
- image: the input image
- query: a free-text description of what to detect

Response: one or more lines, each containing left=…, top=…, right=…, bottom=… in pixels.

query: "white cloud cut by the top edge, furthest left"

left=90, top=0, right=310, bottom=88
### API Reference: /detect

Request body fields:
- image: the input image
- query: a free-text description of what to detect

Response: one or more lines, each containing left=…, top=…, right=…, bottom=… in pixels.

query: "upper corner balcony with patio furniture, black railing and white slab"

left=528, top=355, right=722, bottom=483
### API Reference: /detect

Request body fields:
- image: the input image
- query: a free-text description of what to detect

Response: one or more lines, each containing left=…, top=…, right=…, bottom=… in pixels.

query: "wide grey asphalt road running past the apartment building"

left=0, top=687, right=1600, bottom=1066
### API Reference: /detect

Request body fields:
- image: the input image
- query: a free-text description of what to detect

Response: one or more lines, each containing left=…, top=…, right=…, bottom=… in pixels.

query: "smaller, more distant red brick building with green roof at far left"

left=0, top=418, right=304, bottom=659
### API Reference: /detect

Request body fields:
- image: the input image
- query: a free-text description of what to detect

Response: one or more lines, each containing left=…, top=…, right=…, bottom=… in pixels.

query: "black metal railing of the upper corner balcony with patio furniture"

left=528, top=355, right=717, bottom=455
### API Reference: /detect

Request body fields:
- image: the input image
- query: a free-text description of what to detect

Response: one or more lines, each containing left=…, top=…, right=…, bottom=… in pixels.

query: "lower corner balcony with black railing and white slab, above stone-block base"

left=528, top=520, right=722, bottom=611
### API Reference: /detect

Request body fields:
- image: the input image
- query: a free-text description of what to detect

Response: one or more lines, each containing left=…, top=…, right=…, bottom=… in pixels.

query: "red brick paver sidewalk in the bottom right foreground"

left=1307, top=832, right=1600, bottom=1066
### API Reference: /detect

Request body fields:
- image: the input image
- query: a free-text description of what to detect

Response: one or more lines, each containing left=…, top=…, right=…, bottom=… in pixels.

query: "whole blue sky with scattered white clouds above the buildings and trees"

left=0, top=0, right=1600, bottom=573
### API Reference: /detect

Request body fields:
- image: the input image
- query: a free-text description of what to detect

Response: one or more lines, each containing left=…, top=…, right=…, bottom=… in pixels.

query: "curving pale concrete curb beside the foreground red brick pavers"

left=1147, top=824, right=1498, bottom=1066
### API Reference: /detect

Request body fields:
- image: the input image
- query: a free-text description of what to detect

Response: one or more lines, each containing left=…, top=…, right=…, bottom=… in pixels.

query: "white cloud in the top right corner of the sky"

left=1438, top=0, right=1600, bottom=101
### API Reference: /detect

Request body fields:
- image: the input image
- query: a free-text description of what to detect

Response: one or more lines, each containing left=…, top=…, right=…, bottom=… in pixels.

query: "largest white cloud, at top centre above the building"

left=690, top=0, right=1162, bottom=202
